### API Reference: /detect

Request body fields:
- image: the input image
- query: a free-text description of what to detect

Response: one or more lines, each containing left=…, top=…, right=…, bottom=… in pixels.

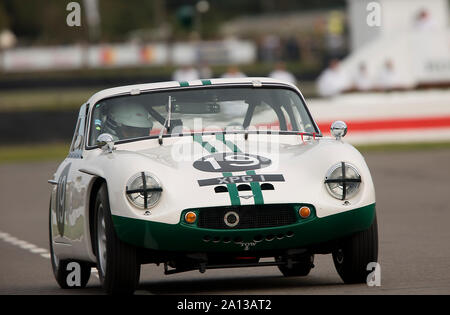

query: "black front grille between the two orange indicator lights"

left=198, top=205, right=297, bottom=229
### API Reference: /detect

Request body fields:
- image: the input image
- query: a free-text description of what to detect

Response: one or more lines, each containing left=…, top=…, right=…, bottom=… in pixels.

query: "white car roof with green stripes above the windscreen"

left=88, top=77, right=300, bottom=108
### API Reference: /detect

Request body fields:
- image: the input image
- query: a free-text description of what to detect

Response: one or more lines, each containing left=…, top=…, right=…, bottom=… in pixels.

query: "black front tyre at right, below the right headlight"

left=333, top=216, right=378, bottom=284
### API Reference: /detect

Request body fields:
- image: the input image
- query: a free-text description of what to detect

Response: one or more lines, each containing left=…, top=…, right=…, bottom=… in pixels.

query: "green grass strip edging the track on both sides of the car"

left=0, top=142, right=450, bottom=164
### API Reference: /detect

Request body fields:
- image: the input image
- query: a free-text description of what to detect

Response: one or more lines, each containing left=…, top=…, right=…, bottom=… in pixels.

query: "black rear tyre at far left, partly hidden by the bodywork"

left=48, top=201, right=91, bottom=289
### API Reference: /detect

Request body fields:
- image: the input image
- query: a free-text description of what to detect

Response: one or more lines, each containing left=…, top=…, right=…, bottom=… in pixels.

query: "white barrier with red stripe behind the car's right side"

left=308, top=89, right=450, bottom=144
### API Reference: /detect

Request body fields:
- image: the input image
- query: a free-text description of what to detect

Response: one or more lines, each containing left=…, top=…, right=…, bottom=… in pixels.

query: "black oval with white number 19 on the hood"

left=193, top=153, right=272, bottom=173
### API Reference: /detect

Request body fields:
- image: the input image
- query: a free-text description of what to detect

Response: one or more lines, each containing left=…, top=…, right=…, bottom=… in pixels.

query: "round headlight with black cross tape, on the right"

left=325, top=162, right=361, bottom=200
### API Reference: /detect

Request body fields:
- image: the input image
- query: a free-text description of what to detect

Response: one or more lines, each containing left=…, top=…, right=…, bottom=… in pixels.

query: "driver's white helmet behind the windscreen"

left=105, top=104, right=153, bottom=140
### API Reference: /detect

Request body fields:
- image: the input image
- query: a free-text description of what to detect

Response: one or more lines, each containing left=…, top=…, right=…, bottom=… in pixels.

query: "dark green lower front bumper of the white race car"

left=113, top=203, right=375, bottom=253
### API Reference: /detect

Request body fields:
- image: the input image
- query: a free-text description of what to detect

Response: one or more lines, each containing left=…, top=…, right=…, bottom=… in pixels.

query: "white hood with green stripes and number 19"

left=86, top=134, right=375, bottom=223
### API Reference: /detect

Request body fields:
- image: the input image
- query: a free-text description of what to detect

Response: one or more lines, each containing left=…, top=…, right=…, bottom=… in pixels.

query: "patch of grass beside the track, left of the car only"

left=0, top=143, right=70, bottom=164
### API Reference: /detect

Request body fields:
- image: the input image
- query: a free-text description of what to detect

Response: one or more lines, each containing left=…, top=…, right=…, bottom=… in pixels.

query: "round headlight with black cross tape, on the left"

left=126, top=172, right=162, bottom=209
